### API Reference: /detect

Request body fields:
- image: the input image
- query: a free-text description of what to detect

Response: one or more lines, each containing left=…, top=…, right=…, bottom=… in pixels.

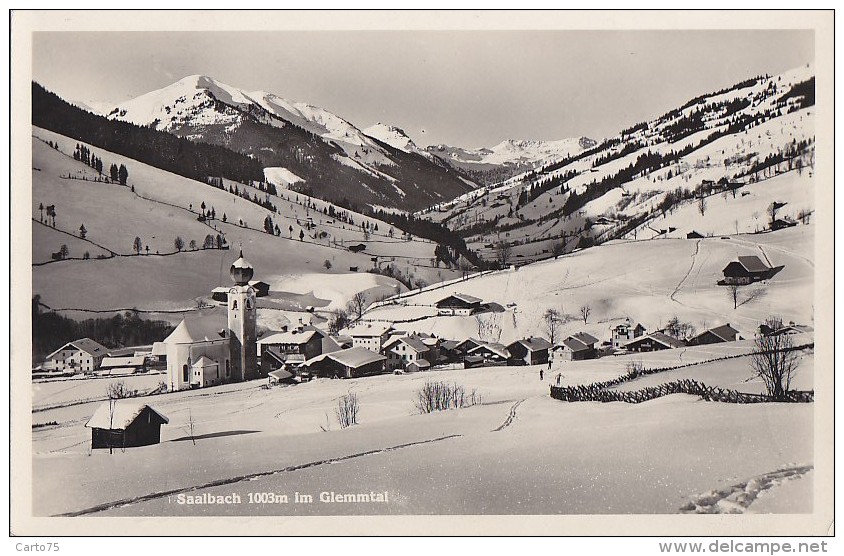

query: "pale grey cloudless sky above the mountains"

left=32, top=30, right=814, bottom=148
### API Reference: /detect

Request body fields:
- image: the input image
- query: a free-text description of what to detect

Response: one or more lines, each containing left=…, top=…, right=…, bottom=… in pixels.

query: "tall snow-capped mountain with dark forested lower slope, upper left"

left=108, top=75, right=473, bottom=209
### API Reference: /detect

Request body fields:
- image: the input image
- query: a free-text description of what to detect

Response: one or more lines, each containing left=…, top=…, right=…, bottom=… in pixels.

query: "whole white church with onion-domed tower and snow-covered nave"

left=162, top=252, right=261, bottom=391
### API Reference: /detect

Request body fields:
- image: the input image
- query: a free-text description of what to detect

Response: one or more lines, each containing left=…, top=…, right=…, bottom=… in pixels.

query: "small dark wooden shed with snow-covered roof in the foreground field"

left=85, top=400, right=170, bottom=448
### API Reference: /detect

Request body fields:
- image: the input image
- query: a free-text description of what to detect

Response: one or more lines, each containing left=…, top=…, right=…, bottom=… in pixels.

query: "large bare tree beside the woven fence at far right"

left=750, top=316, right=800, bottom=400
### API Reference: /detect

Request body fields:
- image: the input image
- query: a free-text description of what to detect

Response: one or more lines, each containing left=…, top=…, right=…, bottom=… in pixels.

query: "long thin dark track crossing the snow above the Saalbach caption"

left=53, top=434, right=463, bottom=517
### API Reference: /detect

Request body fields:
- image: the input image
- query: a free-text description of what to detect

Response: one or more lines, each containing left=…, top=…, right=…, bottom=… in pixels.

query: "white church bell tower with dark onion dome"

left=228, top=251, right=258, bottom=382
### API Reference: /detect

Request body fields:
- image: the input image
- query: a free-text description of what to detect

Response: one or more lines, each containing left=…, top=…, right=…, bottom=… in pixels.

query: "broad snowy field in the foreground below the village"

left=33, top=350, right=814, bottom=516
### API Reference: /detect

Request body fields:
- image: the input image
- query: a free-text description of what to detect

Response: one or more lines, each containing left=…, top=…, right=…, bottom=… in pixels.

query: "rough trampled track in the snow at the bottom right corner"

left=680, top=465, right=814, bottom=514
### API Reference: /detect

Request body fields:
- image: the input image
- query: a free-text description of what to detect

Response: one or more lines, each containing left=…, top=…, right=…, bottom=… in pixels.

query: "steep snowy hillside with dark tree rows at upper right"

left=420, top=66, right=814, bottom=262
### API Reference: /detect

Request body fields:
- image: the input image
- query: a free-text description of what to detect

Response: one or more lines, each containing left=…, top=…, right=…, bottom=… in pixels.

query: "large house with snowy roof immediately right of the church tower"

left=258, top=325, right=341, bottom=375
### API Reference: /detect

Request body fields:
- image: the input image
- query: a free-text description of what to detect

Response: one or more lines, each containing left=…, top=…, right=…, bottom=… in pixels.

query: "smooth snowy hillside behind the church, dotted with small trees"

left=32, top=127, right=468, bottom=326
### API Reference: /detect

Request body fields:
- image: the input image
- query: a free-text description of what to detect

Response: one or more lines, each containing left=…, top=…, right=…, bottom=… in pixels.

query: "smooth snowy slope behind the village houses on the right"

left=365, top=225, right=814, bottom=343
